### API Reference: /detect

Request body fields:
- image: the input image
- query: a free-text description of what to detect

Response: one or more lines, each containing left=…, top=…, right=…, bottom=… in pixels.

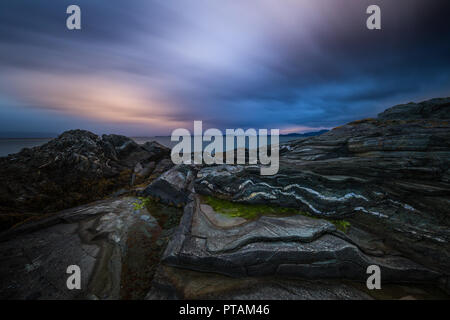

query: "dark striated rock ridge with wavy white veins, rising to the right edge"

left=195, top=98, right=450, bottom=274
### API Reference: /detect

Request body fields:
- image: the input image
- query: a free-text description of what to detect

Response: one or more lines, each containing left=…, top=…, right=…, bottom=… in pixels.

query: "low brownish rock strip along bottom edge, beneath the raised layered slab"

left=146, top=265, right=448, bottom=300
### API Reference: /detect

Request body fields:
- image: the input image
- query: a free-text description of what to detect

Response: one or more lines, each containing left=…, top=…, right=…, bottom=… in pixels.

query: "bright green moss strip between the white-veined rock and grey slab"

left=202, top=196, right=350, bottom=233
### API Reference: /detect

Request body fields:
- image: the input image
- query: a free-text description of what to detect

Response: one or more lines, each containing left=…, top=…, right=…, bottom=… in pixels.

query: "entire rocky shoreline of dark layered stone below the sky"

left=0, top=98, right=450, bottom=299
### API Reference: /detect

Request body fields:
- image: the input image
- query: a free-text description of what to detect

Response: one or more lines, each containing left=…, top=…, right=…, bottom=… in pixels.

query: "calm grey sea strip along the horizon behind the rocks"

left=0, top=136, right=297, bottom=157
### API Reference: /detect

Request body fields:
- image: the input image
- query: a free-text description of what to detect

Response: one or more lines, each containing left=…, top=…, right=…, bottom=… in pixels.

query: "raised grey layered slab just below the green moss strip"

left=162, top=197, right=441, bottom=283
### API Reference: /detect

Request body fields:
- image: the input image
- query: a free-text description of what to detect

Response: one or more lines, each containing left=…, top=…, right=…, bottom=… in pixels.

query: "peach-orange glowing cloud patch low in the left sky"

left=2, top=73, right=186, bottom=129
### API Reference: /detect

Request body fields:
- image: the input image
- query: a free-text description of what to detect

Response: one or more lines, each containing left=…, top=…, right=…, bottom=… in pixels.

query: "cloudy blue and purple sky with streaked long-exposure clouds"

left=0, top=0, right=450, bottom=136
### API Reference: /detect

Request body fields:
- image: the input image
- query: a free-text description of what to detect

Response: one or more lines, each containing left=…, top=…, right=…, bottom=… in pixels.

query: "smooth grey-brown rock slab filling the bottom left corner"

left=0, top=197, right=172, bottom=299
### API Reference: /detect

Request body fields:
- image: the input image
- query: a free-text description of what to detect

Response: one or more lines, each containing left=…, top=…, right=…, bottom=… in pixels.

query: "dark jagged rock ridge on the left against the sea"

left=0, top=130, right=172, bottom=228
